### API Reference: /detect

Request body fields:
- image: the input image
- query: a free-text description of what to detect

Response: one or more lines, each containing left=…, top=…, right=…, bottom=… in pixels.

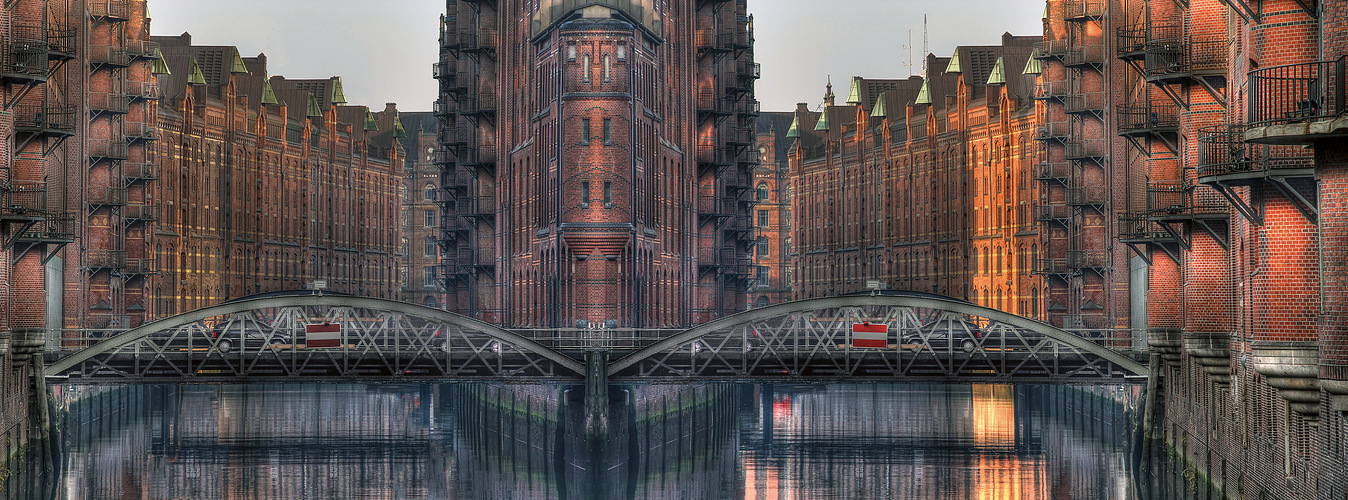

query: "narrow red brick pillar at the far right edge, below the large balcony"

left=1316, top=142, right=1348, bottom=404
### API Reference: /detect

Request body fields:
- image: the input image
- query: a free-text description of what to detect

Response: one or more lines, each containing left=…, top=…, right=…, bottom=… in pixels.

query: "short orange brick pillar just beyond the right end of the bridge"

left=1147, top=251, right=1184, bottom=367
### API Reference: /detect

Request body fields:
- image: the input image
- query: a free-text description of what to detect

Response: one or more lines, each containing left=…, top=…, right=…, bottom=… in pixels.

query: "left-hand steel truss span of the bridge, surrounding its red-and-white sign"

left=49, top=295, right=584, bottom=381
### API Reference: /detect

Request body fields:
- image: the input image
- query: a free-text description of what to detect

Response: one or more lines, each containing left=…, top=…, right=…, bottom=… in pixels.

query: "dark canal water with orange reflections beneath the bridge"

left=0, top=383, right=1213, bottom=500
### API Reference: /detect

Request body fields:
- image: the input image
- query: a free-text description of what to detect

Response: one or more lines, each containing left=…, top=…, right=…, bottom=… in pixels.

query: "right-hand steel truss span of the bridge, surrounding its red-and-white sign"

left=609, top=296, right=1146, bottom=383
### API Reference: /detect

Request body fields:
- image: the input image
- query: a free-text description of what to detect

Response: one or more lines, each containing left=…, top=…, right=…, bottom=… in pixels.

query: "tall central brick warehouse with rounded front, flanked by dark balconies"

left=435, top=0, right=759, bottom=327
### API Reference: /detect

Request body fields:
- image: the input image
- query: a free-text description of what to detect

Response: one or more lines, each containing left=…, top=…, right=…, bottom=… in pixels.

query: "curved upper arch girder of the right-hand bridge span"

left=608, top=294, right=1148, bottom=377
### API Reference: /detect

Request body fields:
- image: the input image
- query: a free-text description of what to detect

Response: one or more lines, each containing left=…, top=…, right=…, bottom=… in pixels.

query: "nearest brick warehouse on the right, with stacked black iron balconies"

left=1039, top=0, right=1348, bottom=499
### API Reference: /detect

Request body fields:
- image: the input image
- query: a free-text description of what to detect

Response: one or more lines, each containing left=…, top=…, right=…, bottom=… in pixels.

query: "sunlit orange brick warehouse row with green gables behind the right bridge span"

left=787, top=34, right=1066, bottom=324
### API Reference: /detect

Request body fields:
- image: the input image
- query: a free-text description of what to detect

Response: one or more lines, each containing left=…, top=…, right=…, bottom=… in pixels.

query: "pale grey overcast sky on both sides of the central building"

left=150, top=0, right=1043, bottom=111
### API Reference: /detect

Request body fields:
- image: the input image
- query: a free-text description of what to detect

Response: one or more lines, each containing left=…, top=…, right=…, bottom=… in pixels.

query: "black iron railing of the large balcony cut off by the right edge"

left=1250, top=55, right=1348, bottom=127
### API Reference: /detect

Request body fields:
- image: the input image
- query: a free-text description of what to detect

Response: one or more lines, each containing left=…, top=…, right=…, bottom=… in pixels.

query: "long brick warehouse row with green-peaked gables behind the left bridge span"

left=148, top=34, right=406, bottom=318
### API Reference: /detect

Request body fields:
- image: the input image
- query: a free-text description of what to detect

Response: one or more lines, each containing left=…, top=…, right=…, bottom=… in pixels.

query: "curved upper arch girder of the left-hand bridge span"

left=46, top=294, right=585, bottom=376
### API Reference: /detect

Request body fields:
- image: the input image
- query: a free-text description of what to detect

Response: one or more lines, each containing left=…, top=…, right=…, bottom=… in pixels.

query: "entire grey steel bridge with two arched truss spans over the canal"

left=46, top=295, right=1147, bottom=383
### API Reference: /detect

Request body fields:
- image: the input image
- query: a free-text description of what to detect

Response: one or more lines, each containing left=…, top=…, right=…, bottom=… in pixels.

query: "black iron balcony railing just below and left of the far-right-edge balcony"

left=1198, top=124, right=1316, bottom=178
